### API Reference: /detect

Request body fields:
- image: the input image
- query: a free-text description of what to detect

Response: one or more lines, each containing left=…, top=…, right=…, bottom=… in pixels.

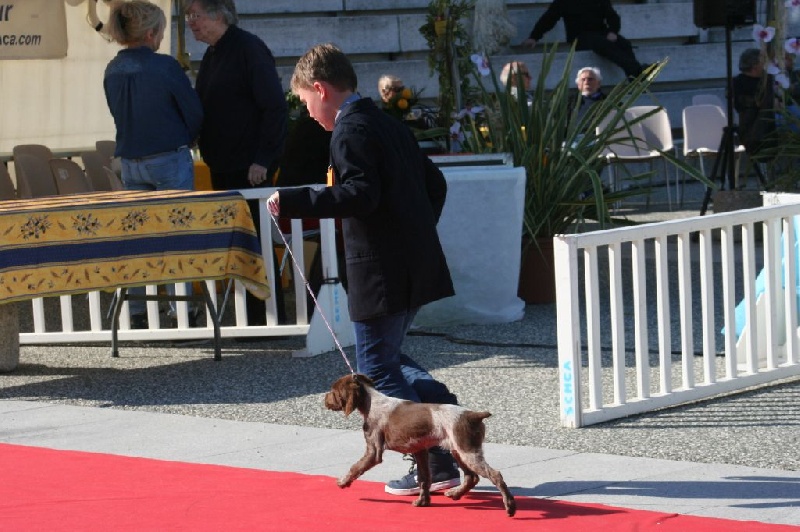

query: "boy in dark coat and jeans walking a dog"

left=268, top=44, right=460, bottom=495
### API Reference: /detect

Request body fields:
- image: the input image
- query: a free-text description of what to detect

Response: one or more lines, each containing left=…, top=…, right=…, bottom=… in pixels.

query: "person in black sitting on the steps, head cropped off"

left=522, top=0, right=645, bottom=77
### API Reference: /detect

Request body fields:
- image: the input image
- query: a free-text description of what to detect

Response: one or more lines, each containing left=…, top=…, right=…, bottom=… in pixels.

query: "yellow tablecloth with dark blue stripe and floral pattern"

left=0, top=191, right=269, bottom=303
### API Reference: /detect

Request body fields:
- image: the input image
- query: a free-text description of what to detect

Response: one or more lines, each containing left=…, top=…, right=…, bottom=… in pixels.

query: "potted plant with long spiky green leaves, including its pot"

left=454, top=45, right=713, bottom=303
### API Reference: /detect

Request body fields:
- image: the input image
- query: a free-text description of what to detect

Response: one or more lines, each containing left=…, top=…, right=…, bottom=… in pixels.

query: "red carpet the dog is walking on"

left=0, top=444, right=797, bottom=532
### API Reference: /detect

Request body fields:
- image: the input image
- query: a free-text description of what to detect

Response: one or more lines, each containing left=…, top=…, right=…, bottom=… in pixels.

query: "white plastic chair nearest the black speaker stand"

left=678, top=104, right=745, bottom=205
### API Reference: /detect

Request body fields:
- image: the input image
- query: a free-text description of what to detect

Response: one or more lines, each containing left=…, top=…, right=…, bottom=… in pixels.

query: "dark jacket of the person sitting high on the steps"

left=530, top=0, right=622, bottom=43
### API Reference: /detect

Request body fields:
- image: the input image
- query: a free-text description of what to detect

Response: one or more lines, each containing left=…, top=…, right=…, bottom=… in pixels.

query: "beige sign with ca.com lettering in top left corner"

left=0, top=0, right=67, bottom=60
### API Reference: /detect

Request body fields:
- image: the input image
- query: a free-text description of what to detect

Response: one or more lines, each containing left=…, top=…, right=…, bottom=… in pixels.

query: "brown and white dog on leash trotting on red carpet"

left=325, top=374, right=517, bottom=516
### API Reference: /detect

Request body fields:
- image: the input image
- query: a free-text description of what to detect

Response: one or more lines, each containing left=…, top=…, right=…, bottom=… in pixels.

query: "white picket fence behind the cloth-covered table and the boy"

left=14, top=188, right=354, bottom=356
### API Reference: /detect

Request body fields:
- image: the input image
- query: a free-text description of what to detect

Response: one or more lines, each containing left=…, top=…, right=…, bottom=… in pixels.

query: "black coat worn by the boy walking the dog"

left=280, top=98, right=454, bottom=321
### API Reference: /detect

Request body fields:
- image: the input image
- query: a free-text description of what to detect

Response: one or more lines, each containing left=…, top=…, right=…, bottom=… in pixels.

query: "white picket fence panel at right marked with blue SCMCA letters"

left=554, top=200, right=800, bottom=427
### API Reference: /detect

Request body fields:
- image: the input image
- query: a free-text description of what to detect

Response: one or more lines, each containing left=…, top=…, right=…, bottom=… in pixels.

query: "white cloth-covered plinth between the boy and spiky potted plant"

left=414, top=156, right=525, bottom=326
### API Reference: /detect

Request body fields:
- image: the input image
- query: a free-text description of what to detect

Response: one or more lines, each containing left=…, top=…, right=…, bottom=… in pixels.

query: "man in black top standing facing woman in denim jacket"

left=186, top=0, right=288, bottom=325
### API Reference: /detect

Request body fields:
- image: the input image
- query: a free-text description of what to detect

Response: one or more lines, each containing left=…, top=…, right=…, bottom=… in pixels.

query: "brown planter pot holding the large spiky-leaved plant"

left=518, top=238, right=556, bottom=305
